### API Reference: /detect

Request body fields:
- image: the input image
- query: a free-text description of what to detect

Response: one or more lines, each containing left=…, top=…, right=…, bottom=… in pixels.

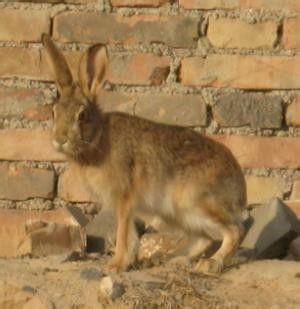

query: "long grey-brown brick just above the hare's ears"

left=53, top=13, right=199, bottom=47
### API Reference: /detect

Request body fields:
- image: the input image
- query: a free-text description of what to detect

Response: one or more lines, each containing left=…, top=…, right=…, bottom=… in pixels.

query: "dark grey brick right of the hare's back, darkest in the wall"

left=213, top=93, right=283, bottom=128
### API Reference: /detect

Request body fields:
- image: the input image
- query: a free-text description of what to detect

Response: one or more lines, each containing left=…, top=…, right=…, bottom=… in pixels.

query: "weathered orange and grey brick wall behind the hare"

left=0, top=0, right=300, bottom=212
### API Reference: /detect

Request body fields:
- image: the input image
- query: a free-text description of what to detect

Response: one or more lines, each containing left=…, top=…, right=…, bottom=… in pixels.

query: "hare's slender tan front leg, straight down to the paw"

left=109, top=200, right=137, bottom=271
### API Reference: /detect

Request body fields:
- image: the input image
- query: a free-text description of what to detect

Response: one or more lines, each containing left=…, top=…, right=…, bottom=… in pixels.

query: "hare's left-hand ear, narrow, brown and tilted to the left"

left=42, top=34, right=74, bottom=96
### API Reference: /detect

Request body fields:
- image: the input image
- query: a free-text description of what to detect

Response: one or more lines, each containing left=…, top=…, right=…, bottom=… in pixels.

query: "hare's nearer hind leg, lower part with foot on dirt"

left=195, top=223, right=243, bottom=274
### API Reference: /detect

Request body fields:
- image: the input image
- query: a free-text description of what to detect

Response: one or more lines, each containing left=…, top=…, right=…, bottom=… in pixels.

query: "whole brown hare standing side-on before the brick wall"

left=43, top=35, right=247, bottom=273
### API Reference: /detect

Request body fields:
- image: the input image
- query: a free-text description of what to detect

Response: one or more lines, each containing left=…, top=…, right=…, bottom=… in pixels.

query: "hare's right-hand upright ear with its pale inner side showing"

left=79, top=44, right=108, bottom=100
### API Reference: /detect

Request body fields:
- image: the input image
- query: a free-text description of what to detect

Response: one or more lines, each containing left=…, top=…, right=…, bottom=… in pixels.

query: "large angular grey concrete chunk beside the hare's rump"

left=241, top=198, right=299, bottom=258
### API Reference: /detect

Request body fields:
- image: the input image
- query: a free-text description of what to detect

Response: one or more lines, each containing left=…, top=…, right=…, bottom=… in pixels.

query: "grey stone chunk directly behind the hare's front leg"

left=86, top=209, right=145, bottom=253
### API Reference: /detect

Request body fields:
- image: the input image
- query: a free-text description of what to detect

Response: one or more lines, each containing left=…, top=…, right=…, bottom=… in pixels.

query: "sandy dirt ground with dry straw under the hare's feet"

left=0, top=255, right=300, bottom=309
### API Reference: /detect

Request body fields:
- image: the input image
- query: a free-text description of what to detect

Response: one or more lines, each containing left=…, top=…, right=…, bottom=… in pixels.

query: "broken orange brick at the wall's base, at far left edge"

left=0, top=207, right=87, bottom=257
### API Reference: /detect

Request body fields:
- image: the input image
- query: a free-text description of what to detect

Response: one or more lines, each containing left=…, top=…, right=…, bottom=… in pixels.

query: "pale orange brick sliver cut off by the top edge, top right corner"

left=179, top=0, right=300, bottom=11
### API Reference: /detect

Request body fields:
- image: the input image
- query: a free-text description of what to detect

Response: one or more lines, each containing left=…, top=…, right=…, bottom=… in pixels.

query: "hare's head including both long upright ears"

left=43, top=34, right=108, bottom=159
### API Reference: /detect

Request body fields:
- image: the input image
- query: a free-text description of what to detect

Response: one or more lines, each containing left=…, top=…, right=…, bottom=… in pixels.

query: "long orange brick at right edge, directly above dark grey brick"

left=180, top=55, right=300, bottom=89
